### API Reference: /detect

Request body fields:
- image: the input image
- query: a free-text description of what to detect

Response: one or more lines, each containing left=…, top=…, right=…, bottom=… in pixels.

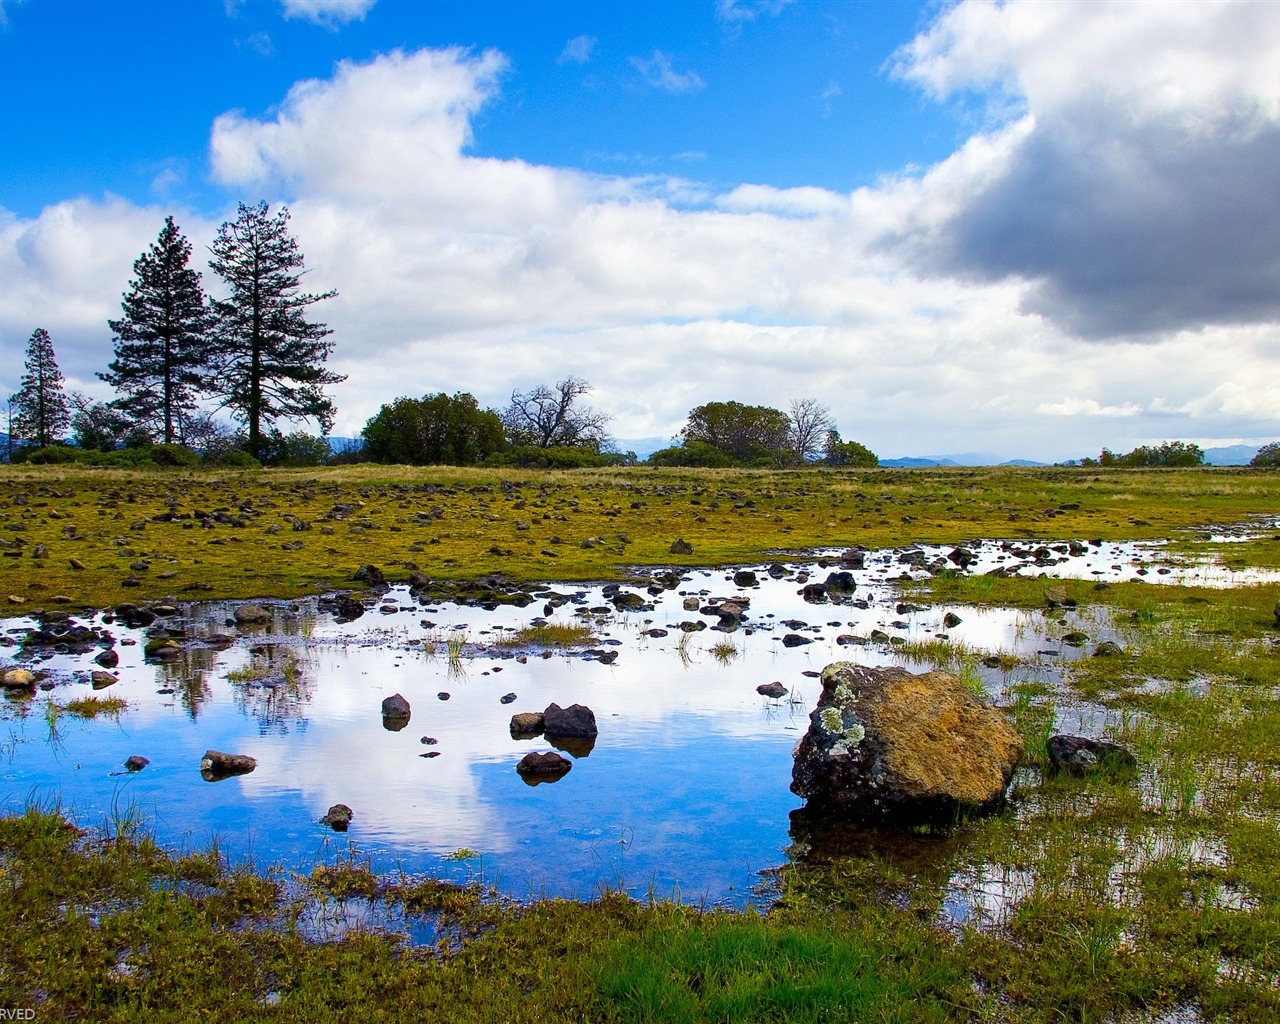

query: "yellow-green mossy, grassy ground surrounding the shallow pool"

left=0, top=468, right=1280, bottom=1021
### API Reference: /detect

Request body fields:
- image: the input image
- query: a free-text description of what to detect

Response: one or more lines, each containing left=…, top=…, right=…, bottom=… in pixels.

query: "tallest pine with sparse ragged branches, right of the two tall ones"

left=209, top=202, right=346, bottom=457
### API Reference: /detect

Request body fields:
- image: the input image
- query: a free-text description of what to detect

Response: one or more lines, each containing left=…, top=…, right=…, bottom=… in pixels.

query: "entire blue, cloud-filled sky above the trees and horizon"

left=0, top=0, right=1280, bottom=461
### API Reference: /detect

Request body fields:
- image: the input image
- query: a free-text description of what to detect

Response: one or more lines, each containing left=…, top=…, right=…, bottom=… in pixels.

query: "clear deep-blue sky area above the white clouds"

left=0, top=0, right=963, bottom=216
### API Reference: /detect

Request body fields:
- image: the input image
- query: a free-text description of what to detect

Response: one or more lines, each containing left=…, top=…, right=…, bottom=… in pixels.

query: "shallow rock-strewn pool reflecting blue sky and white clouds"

left=0, top=535, right=1259, bottom=901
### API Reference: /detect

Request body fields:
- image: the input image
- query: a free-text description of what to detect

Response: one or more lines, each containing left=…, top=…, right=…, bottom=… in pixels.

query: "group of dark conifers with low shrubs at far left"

left=9, top=202, right=344, bottom=461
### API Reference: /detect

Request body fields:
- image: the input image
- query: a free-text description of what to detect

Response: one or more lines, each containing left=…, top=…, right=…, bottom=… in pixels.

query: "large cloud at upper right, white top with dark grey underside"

left=896, top=0, right=1280, bottom=338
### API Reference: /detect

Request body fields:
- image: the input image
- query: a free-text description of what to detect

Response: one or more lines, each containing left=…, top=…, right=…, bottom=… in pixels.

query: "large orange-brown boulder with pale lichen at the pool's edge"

left=791, top=662, right=1023, bottom=823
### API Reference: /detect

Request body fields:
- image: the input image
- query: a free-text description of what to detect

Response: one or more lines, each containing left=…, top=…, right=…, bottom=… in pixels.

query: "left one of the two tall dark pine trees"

left=99, top=216, right=210, bottom=444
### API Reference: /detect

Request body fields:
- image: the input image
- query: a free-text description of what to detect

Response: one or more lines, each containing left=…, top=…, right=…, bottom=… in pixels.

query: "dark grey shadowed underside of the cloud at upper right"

left=920, top=116, right=1280, bottom=339
